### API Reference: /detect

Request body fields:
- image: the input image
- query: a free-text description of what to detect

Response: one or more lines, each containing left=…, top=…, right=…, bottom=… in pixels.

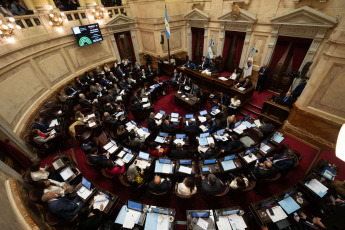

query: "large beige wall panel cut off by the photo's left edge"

left=0, top=62, right=46, bottom=128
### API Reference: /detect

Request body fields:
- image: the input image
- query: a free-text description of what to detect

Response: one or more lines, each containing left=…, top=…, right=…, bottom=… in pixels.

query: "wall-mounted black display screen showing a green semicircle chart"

left=72, top=23, right=103, bottom=47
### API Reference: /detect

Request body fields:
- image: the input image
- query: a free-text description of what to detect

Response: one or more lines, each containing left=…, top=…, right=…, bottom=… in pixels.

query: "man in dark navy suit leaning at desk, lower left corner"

left=42, top=192, right=85, bottom=221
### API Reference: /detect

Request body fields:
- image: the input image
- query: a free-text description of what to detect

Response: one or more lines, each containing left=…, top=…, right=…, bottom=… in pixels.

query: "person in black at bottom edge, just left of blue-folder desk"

left=78, top=203, right=106, bottom=230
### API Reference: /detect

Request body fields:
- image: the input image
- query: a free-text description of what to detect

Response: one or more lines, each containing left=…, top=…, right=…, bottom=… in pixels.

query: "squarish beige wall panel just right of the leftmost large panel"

left=34, top=50, right=71, bottom=85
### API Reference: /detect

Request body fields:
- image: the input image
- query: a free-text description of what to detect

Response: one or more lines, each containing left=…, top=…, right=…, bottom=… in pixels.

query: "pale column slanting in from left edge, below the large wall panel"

left=0, top=121, right=39, bottom=161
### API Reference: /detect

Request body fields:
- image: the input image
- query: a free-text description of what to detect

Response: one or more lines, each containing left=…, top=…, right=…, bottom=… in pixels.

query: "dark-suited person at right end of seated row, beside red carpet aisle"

left=269, top=149, right=295, bottom=172
